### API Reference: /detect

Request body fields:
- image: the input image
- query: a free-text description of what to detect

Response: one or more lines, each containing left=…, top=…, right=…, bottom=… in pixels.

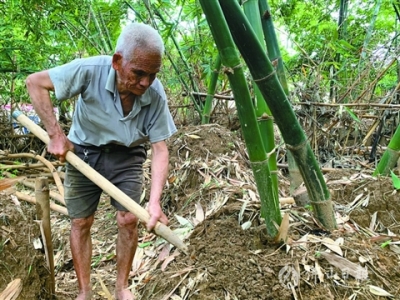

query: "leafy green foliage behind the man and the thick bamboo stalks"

left=0, top=0, right=400, bottom=122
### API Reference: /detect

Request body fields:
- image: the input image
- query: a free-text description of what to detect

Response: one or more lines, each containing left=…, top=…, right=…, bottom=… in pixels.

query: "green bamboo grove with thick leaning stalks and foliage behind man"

left=0, top=0, right=400, bottom=237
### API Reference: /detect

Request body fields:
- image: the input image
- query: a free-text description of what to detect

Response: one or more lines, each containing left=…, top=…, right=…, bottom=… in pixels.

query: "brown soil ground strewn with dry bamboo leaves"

left=0, top=125, right=400, bottom=300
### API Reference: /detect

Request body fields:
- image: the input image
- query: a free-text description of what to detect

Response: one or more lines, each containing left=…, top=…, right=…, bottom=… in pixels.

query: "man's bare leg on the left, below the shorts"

left=70, top=215, right=94, bottom=300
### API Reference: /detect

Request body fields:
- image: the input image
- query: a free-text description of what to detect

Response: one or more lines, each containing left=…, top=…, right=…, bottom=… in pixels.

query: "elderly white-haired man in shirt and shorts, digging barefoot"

left=26, top=23, right=176, bottom=300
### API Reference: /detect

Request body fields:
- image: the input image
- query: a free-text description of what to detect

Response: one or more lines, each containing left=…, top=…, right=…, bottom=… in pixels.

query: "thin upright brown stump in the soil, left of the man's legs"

left=35, top=177, right=56, bottom=295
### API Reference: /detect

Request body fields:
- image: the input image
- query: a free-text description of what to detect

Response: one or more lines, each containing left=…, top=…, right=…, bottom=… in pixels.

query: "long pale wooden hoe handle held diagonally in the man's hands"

left=12, top=111, right=188, bottom=254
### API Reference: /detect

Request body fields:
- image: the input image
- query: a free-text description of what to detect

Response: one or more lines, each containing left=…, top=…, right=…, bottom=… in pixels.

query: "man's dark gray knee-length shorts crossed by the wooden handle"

left=64, top=144, right=146, bottom=218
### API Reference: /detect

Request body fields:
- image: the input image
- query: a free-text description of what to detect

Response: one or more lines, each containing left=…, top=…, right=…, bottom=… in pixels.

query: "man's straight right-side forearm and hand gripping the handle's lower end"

left=147, top=141, right=168, bottom=230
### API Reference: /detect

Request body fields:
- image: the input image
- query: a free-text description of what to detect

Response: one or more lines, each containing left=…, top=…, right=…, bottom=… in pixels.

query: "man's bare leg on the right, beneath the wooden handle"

left=115, top=211, right=138, bottom=300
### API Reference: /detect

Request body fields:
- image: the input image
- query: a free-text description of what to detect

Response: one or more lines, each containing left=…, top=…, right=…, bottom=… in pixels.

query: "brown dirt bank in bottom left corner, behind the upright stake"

left=0, top=193, right=50, bottom=300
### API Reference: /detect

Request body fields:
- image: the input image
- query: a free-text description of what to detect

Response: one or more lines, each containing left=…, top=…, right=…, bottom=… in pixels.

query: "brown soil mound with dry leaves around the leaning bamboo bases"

left=140, top=171, right=400, bottom=300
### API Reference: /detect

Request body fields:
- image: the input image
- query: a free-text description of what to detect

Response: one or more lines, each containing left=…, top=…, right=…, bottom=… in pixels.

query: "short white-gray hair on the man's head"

left=115, top=23, right=164, bottom=60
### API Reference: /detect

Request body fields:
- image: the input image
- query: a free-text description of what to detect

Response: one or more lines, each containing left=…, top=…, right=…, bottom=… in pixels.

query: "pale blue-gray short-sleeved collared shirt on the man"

left=49, top=55, right=176, bottom=147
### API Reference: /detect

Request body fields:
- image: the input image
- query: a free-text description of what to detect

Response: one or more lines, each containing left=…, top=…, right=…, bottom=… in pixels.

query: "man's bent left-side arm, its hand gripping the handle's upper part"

left=26, top=71, right=74, bottom=162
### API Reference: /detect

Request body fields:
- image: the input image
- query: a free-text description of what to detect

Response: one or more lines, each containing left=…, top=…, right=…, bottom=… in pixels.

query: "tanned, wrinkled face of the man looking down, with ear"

left=112, top=49, right=161, bottom=96
